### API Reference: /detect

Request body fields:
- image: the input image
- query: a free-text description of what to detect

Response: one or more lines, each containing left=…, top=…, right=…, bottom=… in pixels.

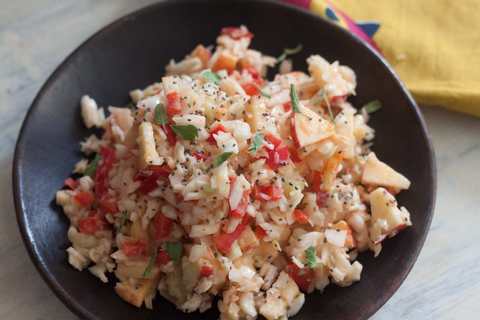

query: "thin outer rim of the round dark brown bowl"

left=12, top=0, right=437, bottom=320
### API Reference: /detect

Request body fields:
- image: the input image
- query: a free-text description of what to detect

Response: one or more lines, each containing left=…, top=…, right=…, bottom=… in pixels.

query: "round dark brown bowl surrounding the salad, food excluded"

left=13, top=0, right=436, bottom=320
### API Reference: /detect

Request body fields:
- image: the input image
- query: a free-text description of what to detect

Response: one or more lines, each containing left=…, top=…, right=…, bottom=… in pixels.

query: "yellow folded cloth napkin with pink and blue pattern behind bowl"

left=287, top=0, right=480, bottom=117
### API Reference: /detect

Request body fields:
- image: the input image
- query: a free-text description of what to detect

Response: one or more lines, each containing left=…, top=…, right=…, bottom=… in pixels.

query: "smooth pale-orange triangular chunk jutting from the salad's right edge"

left=362, top=152, right=410, bottom=190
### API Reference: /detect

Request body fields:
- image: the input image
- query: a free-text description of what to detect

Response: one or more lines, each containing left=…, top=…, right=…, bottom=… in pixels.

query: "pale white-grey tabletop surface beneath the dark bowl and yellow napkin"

left=0, top=0, right=480, bottom=320
